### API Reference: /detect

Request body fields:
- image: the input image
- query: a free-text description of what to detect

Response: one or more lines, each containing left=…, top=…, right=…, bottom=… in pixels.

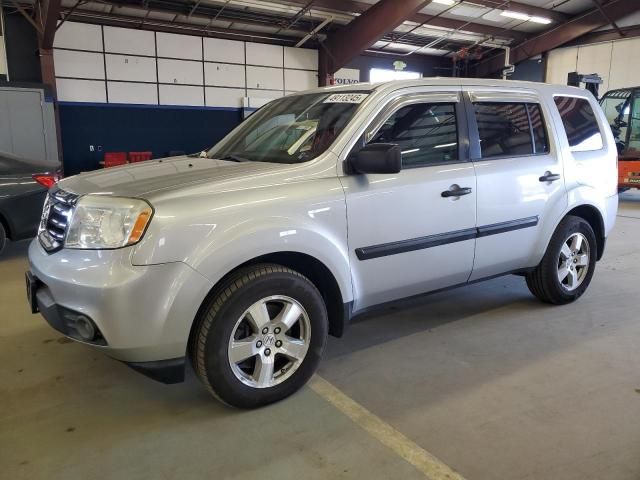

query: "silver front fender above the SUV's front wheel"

left=132, top=182, right=353, bottom=302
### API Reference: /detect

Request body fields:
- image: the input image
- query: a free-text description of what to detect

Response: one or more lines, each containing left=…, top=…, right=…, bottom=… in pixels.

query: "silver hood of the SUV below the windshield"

left=58, top=156, right=291, bottom=198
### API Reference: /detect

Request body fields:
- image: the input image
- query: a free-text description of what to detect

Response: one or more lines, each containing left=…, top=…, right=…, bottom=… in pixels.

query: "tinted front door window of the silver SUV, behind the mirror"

left=369, top=103, right=458, bottom=167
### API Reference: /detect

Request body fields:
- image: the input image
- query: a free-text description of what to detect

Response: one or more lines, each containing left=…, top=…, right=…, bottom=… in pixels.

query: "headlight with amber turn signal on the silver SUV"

left=64, top=195, right=153, bottom=249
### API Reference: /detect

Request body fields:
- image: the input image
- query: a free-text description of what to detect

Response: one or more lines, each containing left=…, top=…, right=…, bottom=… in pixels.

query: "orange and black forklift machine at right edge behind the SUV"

left=600, top=87, right=640, bottom=191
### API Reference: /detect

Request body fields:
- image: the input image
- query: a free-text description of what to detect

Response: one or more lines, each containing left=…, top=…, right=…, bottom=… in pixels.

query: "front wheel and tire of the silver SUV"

left=189, top=264, right=328, bottom=408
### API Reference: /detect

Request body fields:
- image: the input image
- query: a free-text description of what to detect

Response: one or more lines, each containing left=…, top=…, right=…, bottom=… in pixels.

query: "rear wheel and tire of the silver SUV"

left=526, top=215, right=597, bottom=305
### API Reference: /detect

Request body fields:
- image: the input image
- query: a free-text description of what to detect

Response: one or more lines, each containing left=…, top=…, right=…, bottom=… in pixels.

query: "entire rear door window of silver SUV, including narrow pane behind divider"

left=474, top=102, right=549, bottom=158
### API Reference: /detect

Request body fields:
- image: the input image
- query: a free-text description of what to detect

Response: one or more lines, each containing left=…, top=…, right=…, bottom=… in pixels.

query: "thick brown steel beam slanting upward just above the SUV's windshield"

left=323, top=0, right=431, bottom=74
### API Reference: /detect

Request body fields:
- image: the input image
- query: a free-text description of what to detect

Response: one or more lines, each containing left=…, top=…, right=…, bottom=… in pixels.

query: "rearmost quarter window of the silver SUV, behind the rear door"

left=553, top=97, right=604, bottom=152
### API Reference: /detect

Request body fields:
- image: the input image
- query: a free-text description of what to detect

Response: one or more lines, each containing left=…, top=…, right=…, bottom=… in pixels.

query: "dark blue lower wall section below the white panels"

left=59, top=102, right=242, bottom=176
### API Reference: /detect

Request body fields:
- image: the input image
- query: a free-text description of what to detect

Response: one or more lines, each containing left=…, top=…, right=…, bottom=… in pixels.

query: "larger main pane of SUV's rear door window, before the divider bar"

left=474, top=103, right=533, bottom=158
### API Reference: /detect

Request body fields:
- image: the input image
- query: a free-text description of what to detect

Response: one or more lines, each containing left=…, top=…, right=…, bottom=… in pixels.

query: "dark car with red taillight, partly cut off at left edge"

left=0, top=152, right=60, bottom=253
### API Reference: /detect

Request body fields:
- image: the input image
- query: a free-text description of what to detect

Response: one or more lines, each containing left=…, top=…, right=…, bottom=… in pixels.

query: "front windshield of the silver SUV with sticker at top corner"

left=207, top=91, right=368, bottom=163
